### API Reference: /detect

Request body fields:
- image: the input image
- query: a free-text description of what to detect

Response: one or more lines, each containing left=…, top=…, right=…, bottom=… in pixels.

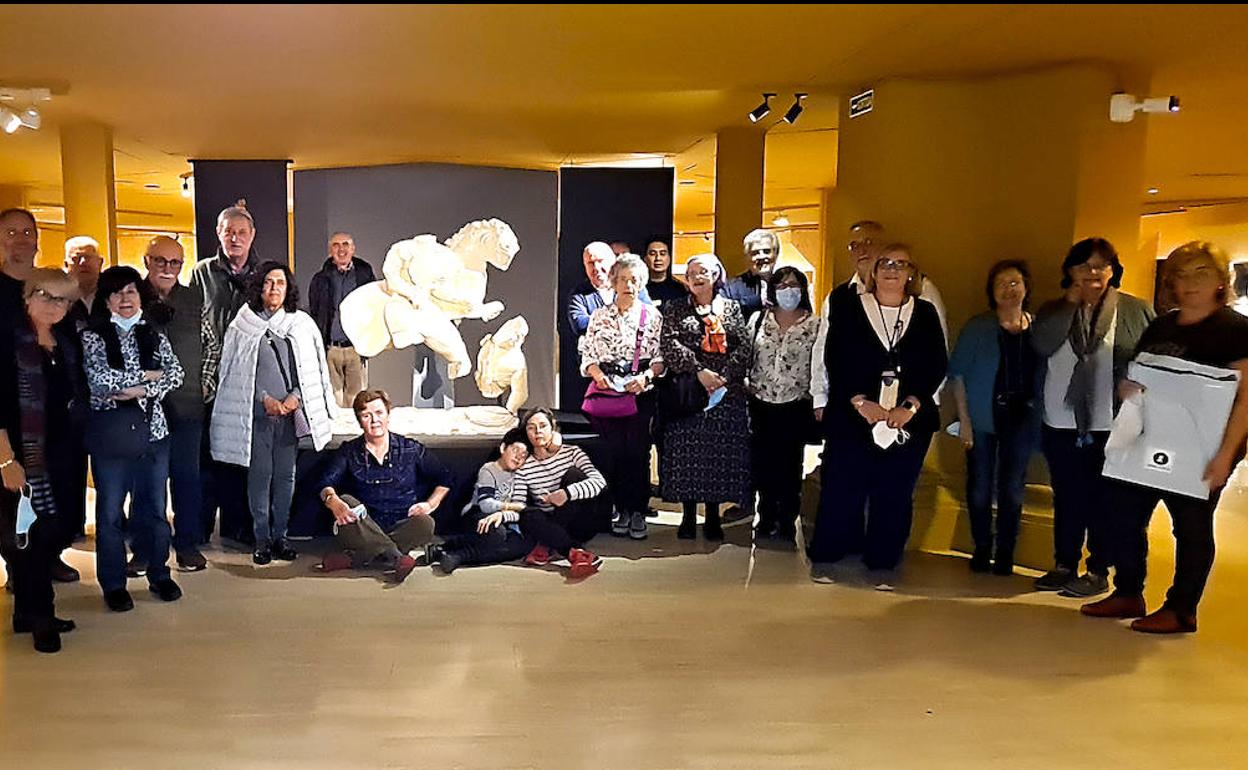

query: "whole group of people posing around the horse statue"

left=0, top=199, right=1248, bottom=651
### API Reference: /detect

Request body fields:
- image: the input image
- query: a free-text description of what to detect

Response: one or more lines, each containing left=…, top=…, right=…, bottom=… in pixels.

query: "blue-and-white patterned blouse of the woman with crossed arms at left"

left=82, top=326, right=185, bottom=442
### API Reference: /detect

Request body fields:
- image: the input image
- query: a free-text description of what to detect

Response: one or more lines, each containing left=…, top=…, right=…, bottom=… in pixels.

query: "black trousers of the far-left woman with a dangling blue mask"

left=0, top=488, right=70, bottom=625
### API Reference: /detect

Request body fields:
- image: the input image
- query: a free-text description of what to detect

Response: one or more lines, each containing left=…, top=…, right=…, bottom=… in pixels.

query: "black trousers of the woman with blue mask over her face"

left=750, top=396, right=811, bottom=530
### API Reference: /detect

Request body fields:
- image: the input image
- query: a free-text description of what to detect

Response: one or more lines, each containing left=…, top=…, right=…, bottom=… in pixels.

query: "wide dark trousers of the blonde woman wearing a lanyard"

left=810, top=431, right=932, bottom=569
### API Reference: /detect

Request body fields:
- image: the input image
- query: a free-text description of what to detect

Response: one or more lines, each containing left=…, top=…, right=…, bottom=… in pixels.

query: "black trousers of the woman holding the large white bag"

left=1107, top=480, right=1222, bottom=615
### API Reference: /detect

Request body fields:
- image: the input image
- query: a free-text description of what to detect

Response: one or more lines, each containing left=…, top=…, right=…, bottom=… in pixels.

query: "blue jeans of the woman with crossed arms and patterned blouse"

left=91, top=438, right=170, bottom=592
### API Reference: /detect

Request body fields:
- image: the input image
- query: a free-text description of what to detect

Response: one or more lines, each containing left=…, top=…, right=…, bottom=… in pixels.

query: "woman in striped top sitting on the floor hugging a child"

left=510, top=408, right=607, bottom=579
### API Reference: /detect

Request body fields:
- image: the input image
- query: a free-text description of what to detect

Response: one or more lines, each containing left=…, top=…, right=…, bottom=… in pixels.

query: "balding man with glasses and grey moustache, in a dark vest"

left=131, top=236, right=207, bottom=574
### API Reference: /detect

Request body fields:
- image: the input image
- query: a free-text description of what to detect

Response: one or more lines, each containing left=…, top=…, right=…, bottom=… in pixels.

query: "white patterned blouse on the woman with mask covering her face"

left=750, top=311, right=819, bottom=404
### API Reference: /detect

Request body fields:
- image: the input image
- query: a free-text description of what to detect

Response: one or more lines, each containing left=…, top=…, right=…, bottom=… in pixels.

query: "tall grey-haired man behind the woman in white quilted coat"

left=183, top=205, right=261, bottom=545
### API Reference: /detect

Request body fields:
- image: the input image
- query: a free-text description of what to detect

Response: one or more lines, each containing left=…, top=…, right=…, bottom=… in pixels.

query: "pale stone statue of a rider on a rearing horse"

left=339, top=220, right=520, bottom=379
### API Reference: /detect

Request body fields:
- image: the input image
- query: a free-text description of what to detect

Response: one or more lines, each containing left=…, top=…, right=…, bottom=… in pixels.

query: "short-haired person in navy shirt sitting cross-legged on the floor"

left=321, top=391, right=452, bottom=583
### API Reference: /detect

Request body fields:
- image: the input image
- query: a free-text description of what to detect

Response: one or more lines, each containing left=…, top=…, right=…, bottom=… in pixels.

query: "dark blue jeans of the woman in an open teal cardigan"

left=966, top=426, right=1035, bottom=564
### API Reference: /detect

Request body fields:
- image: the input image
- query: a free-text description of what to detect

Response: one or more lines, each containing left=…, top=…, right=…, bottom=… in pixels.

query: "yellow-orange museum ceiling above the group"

left=0, top=5, right=1248, bottom=232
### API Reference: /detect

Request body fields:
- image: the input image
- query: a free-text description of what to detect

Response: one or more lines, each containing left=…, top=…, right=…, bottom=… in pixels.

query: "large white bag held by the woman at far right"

left=1103, top=353, right=1239, bottom=499
